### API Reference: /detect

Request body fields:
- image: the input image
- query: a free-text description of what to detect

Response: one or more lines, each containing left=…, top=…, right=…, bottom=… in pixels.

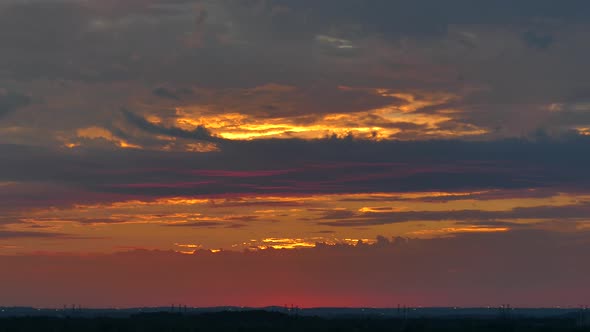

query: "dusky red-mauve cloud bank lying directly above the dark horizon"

left=0, top=231, right=590, bottom=307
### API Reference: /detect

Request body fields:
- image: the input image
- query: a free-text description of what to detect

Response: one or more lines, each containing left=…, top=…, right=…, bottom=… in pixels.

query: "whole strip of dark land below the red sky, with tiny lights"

left=0, top=307, right=590, bottom=332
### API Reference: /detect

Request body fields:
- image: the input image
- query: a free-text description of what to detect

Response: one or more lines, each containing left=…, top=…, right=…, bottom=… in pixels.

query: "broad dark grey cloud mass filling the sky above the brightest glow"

left=0, top=0, right=590, bottom=141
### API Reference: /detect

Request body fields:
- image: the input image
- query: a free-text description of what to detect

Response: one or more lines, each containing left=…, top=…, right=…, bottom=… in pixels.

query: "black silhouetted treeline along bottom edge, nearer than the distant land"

left=0, top=311, right=590, bottom=332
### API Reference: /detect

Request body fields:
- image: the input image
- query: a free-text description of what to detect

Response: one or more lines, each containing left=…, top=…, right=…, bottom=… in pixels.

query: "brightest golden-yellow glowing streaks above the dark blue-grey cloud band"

left=164, top=87, right=487, bottom=140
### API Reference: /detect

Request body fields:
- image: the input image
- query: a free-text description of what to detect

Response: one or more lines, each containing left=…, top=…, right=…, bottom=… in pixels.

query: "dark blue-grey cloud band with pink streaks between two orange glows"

left=0, top=135, right=590, bottom=208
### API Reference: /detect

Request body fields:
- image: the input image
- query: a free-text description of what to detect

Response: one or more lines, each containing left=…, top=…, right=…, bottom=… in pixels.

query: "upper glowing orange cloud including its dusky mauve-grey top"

left=126, top=87, right=488, bottom=145
